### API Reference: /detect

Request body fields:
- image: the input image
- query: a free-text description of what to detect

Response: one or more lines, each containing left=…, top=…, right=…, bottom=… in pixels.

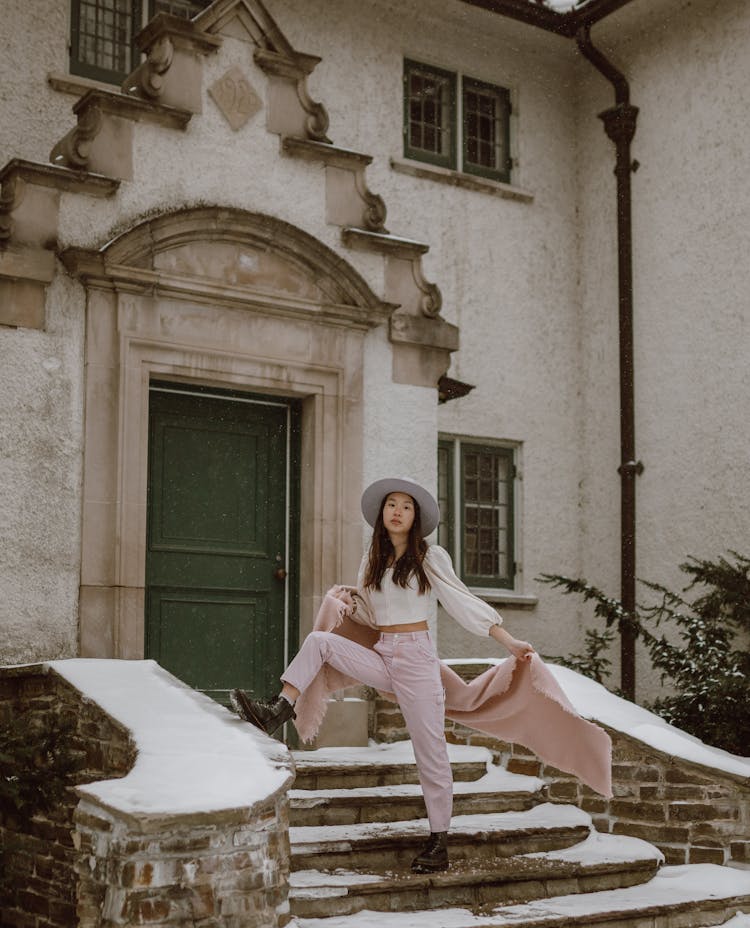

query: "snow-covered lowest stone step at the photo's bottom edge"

left=289, top=864, right=750, bottom=928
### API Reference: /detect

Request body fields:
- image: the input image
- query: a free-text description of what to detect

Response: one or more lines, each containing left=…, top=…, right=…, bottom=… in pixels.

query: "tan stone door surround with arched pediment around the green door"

left=63, top=207, right=393, bottom=676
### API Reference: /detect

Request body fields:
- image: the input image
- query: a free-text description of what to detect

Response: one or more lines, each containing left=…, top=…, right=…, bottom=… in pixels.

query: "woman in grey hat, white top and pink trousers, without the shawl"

left=231, top=477, right=534, bottom=873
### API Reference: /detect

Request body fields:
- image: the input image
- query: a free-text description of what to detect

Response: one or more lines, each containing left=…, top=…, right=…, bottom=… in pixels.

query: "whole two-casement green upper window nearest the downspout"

left=404, top=59, right=511, bottom=183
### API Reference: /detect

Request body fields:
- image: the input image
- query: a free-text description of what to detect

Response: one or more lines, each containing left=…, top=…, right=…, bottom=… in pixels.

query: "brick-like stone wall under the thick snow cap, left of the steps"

left=0, top=665, right=291, bottom=928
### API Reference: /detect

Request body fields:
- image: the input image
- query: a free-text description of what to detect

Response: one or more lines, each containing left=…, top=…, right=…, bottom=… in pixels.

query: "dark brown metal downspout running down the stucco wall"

left=576, top=26, right=643, bottom=700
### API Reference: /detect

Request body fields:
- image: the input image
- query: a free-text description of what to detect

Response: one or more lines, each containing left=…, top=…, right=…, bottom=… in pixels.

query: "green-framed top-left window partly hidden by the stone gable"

left=70, top=0, right=211, bottom=85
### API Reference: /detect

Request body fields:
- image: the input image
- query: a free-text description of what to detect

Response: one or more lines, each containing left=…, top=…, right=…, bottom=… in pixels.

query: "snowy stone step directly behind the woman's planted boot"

left=289, top=803, right=591, bottom=872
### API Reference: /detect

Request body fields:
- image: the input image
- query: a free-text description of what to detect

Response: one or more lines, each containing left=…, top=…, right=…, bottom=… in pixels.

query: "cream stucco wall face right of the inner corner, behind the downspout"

left=578, top=0, right=750, bottom=692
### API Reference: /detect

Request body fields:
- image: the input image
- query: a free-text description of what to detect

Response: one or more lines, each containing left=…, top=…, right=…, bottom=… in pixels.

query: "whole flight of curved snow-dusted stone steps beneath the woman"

left=289, top=742, right=724, bottom=928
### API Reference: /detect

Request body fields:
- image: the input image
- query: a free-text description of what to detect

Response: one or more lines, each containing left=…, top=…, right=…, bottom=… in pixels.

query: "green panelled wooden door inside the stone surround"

left=145, top=385, right=294, bottom=703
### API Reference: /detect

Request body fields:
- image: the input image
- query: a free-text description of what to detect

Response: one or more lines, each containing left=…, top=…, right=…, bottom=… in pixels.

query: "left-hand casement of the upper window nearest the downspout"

left=403, top=60, right=457, bottom=170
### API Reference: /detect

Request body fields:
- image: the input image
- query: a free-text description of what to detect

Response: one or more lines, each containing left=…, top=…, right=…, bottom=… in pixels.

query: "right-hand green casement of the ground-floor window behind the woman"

left=461, top=443, right=515, bottom=589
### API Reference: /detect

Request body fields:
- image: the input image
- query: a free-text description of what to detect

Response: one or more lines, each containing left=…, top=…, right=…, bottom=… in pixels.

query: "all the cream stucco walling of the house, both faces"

left=0, top=0, right=750, bottom=696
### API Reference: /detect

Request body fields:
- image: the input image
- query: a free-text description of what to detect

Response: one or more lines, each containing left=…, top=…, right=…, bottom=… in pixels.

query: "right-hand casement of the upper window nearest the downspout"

left=461, top=78, right=511, bottom=183
